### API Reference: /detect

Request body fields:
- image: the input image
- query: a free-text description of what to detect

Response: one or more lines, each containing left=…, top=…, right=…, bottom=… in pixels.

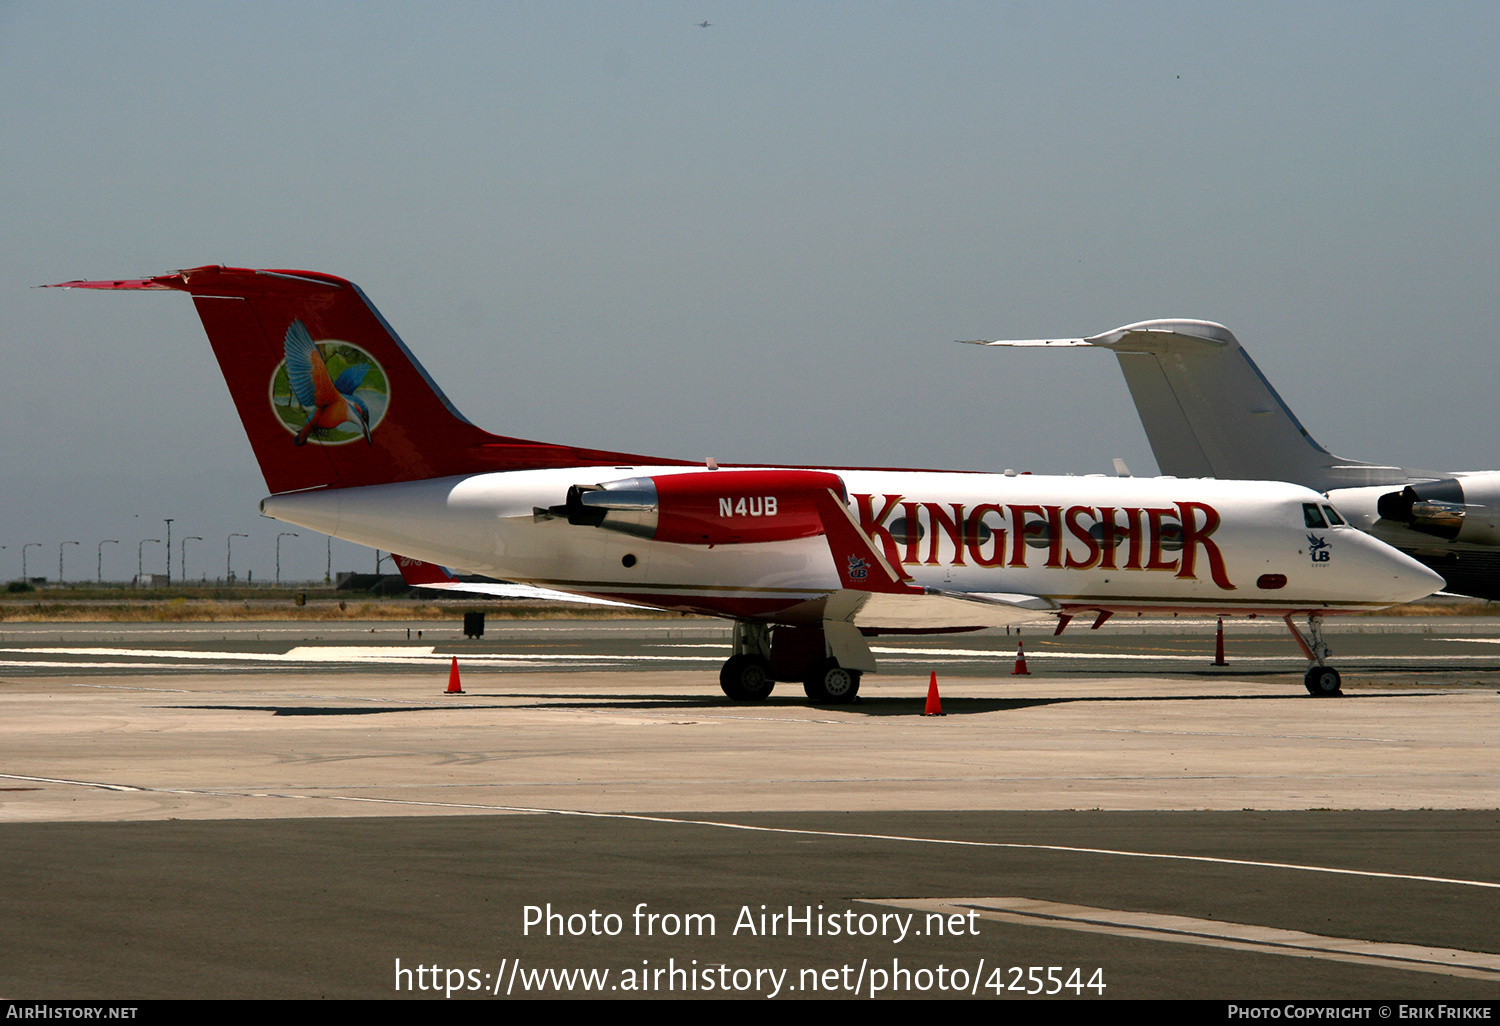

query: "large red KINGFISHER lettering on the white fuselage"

left=852, top=494, right=1236, bottom=591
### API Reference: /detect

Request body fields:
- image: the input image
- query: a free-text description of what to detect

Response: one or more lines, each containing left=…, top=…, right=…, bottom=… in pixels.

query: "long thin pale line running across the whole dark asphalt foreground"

left=0, top=773, right=1500, bottom=891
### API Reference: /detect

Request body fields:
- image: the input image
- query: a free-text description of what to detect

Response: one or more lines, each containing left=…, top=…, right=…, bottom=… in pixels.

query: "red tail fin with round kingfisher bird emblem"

left=49, top=266, right=678, bottom=492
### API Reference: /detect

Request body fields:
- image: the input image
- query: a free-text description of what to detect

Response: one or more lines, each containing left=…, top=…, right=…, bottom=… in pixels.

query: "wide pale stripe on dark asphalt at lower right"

left=855, top=897, right=1500, bottom=980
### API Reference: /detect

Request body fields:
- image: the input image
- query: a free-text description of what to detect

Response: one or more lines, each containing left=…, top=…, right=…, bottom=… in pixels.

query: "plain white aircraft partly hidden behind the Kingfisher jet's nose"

left=966, top=320, right=1500, bottom=599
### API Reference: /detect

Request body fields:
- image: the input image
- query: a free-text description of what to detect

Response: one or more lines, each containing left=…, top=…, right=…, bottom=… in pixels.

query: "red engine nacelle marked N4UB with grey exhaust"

left=537, top=470, right=848, bottom=545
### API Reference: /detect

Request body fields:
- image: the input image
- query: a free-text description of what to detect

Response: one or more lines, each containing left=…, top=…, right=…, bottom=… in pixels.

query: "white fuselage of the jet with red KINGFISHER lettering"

left=263, top=467, right=1437, bottom=626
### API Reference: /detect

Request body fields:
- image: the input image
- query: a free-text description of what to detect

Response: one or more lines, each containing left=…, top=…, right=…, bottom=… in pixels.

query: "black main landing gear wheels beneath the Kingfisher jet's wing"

left=719, top=621, right=873, bottom=705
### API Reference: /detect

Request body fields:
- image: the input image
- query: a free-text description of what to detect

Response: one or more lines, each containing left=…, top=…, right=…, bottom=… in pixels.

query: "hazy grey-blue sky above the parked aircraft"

left=0, top=0, right=1500, bottom=579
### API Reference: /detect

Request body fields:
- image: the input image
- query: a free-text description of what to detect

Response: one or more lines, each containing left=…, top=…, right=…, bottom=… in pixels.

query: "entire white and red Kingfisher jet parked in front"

left=52, top=267, right=1443, bottom=702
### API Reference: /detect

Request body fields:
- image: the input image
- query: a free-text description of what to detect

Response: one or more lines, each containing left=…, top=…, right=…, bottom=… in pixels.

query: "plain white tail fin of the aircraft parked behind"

left=977, top=320, right=1406, bottom=491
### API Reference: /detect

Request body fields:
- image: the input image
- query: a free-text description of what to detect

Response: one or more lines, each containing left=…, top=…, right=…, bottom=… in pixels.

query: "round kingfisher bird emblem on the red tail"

left=270, top=321, right=390, bottom=446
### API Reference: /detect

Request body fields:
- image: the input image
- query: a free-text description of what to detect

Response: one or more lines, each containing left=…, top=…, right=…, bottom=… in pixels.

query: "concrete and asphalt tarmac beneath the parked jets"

left=0, top=620, right=1500, bottom=1001
